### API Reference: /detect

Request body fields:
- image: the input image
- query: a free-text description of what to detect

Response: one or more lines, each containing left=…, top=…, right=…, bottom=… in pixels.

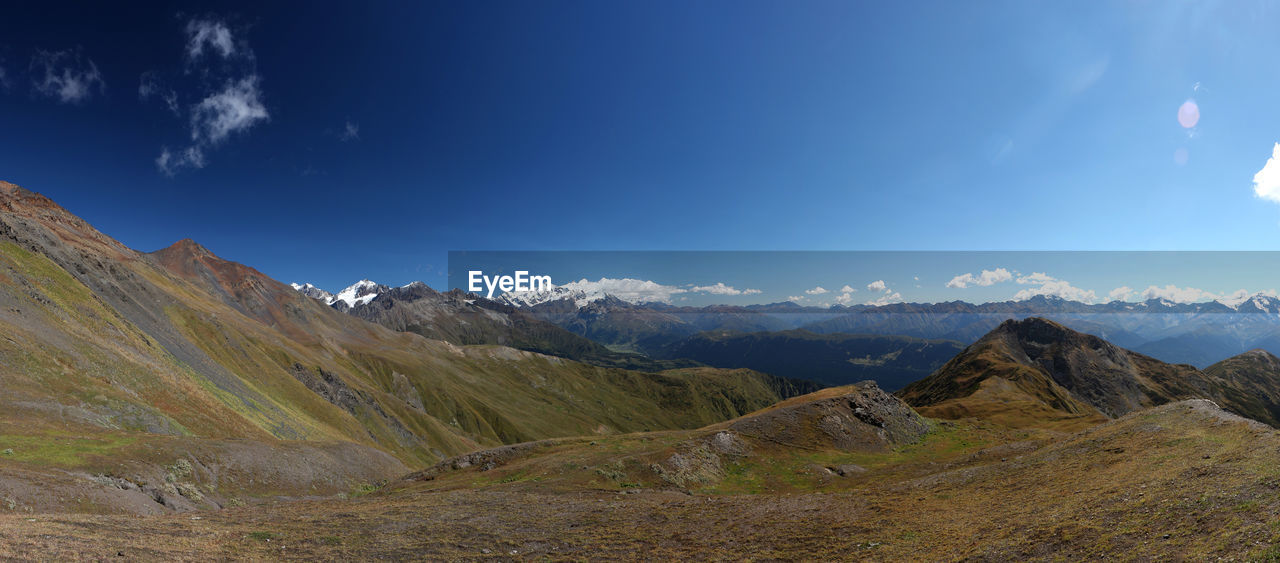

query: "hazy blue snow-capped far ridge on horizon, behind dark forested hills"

left=296, top=282, right=1280, bottom=373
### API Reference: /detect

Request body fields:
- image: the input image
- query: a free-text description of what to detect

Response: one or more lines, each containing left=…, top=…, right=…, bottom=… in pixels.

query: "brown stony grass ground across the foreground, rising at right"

left=0, top=402, right=1280, bottom=560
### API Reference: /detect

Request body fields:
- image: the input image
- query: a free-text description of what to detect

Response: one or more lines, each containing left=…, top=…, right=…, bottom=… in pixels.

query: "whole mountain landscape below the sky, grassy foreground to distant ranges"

left=0, top=184, right=1280, bottom=560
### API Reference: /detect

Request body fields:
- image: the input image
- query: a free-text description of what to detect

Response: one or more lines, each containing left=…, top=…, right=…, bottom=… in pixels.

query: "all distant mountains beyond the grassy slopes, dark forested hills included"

left=293, top=280, right=1280, bottom=390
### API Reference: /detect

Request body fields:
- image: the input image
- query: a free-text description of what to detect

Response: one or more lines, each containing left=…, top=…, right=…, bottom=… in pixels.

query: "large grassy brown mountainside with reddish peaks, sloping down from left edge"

left=0, top=183, right=809, bottom=508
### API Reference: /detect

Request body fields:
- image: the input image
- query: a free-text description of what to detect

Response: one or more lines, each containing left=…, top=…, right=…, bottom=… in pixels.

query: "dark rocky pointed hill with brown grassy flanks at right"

left=899, top=317, right=1277, bottom=429
